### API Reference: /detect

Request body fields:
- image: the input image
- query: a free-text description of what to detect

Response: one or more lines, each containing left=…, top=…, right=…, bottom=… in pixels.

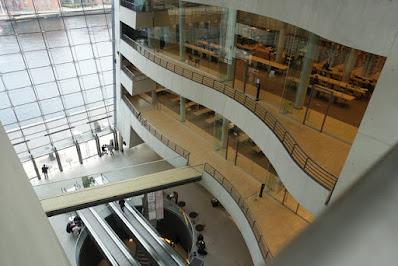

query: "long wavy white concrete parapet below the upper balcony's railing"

left=120, top=40, right=328, bottom=214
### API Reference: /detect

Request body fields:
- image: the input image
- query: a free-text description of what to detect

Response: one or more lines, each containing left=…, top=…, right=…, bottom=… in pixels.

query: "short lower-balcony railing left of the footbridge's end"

left=122, top=95, right=190, bottom=164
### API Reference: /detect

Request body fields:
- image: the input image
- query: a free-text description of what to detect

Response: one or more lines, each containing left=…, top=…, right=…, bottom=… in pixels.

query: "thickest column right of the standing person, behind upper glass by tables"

left=294, top=33, right=319, bottom=109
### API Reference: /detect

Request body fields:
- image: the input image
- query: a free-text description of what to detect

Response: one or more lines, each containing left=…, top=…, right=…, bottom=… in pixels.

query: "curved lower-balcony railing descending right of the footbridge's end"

left=203, top=163, right=273, bottom=261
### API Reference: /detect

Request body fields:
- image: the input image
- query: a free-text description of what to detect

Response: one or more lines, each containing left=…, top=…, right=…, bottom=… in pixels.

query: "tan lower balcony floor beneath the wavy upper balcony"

left=134, top=98, right=313, bottom=255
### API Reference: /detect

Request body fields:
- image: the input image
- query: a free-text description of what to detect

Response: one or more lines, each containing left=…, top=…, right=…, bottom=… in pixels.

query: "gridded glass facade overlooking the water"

left=0, top=0, right=114, bottom=178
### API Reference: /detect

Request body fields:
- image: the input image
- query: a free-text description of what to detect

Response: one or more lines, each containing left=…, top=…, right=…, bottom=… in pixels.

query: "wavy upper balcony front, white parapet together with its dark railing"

left=120, top=36, right=337, bottom=213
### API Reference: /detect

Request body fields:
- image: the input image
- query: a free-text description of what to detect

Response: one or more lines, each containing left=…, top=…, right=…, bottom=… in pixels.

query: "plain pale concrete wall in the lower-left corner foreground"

left=0, top=125, right=69, bottom=266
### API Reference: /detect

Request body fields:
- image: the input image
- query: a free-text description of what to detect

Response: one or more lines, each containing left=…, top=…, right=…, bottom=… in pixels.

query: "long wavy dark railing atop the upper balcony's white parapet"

left=122, top=34, right=338, bottom=200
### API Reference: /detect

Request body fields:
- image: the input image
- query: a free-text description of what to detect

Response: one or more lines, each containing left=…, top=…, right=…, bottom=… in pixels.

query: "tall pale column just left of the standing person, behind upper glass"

left=220, top=8, right=237, bottom=80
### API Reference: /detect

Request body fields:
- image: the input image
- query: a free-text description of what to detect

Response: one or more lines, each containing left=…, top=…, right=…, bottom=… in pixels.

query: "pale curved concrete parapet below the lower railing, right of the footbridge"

left=199, top=173, right=267, bottom=266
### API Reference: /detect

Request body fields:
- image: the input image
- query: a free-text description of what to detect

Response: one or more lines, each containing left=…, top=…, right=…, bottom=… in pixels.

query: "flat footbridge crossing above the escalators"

left=41, top=167, right=202, bottom=216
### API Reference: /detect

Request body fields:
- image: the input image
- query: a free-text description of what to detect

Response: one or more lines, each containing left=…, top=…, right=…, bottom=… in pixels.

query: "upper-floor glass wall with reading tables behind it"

left=121, top=0, right=386, bottom=143
